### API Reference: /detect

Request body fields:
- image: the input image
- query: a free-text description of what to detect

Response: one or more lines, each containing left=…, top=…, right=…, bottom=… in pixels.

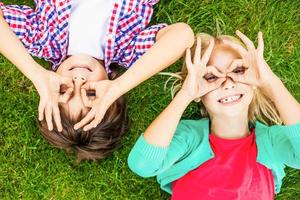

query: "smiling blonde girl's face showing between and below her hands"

left=202, top=44, right=253, bottom=117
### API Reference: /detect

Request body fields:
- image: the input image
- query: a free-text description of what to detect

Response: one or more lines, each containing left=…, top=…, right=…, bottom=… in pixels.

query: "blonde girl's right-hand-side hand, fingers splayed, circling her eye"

left=224, top=31, right=276, bottom=88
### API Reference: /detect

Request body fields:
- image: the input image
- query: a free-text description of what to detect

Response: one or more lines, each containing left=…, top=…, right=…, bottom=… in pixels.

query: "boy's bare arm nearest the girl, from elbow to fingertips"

left=75, top=23, right=194, bottom=130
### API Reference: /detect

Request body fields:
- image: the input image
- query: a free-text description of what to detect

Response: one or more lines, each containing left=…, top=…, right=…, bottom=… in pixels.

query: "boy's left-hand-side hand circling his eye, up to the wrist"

left=33, top=68, right=74, bottom=131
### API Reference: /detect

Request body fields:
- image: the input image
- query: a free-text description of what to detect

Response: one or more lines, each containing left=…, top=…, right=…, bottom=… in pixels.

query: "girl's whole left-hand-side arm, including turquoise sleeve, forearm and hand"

left=128, top=38, right=225, bottom=177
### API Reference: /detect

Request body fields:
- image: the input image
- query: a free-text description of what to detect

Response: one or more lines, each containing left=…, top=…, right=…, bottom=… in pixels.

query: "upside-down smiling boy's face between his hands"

left=56, top=54, right=108, bottom=121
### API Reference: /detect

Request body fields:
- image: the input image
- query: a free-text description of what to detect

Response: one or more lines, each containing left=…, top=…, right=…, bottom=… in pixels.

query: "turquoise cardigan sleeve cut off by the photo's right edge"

left=269, top=123, right=300, bottom=169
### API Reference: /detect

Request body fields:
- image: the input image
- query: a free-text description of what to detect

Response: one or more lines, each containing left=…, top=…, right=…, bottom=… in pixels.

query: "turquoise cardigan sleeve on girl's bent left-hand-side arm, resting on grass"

left=128, top=120, right=195, bottom=177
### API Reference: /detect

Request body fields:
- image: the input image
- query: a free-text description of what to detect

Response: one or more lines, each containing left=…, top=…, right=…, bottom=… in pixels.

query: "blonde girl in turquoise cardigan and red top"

left=128, top=31, right=300, bottom=200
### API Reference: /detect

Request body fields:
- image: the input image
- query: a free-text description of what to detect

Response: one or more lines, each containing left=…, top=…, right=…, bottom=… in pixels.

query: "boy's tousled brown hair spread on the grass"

left=38, top=65, right=129, bottom=162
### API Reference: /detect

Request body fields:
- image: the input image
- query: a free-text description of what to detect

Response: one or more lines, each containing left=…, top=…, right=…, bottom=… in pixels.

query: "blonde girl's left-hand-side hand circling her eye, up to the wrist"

left=181, top=37, right=225, bottom=101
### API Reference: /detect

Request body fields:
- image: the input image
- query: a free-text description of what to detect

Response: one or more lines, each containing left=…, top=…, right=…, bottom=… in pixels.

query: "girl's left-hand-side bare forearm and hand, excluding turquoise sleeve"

left=144, top=37, right=225, bottom=146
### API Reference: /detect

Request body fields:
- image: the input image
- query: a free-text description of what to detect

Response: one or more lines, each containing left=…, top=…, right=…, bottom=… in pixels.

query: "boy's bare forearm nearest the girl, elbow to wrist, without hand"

left=115, top=23, right=194, bottom=94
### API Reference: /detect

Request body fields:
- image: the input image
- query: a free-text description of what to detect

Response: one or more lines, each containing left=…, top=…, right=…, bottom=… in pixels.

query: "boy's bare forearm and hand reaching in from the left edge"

left=0, top=9, right=73, bottom=131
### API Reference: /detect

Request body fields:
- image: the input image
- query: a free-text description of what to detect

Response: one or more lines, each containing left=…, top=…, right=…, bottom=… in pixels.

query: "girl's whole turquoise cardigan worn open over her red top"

left=128, top=118, right=300, bottom=194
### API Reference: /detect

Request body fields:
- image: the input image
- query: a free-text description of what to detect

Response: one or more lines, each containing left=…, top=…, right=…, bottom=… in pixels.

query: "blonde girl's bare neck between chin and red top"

left=211, top=115, right=249, bottom=139
